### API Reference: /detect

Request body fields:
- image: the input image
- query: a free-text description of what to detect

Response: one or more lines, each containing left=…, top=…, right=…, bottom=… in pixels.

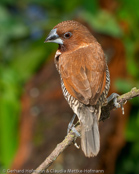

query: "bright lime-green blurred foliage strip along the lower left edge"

left=0, top=67, right=21, bottom=167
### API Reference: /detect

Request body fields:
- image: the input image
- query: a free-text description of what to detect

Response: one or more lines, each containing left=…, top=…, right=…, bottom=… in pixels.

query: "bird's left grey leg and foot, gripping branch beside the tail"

left=67, top=114, right=80, bottom=149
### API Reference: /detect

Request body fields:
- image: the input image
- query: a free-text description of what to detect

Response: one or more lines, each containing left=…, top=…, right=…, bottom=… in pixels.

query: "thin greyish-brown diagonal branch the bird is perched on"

left=32, top=88, right=139, bottom=174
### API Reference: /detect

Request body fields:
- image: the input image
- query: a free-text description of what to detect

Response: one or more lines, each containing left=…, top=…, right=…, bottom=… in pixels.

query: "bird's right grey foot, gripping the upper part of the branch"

left=107, top=93, right=125, bottom=115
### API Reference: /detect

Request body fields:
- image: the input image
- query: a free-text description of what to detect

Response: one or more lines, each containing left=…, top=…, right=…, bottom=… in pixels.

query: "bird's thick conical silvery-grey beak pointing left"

left=44, top=28, right=63, bottom=44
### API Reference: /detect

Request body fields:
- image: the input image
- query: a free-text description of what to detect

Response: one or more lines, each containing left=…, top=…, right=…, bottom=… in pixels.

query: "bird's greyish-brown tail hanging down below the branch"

left=80, top=107, right=101, bottom=157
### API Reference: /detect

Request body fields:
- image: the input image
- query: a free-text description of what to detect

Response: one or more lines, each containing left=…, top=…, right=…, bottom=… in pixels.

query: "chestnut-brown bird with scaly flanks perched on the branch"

left=45, top=20, right=113, bottom=157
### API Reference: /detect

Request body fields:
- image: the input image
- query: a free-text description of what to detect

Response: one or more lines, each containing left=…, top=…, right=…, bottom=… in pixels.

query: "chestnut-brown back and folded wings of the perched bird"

left=59, top=45, right=106, bottom=105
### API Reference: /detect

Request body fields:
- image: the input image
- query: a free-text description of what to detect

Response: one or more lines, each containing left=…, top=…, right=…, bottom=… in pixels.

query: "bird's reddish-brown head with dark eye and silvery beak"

left=45, top=21, right=94, bottom=51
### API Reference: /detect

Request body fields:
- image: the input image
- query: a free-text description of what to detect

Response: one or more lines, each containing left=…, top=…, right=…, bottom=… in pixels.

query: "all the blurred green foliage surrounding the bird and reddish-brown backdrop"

left=0, top=0, right=139, bottom=174
